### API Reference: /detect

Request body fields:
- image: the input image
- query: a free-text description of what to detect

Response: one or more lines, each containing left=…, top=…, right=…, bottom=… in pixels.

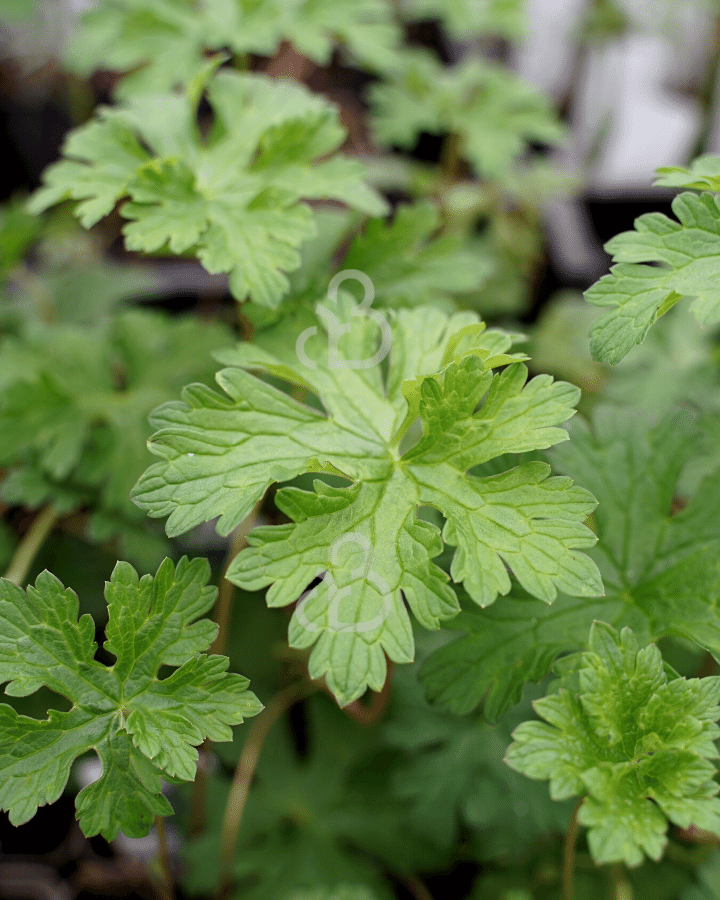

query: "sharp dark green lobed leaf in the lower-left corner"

left=0, top=557, right=262, bottom=840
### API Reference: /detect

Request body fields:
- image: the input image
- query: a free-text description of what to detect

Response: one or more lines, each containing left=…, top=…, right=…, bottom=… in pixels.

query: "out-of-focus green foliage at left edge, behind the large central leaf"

left=0, top=310, right=230, bottom=567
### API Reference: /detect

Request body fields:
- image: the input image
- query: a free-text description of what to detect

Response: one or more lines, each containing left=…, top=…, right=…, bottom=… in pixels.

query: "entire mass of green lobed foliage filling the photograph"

left=0, top=0, right=720, bottom=900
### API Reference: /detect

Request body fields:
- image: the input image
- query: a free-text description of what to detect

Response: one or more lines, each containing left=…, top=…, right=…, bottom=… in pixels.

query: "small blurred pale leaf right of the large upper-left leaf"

left=370, top=50, right=564, bottom=178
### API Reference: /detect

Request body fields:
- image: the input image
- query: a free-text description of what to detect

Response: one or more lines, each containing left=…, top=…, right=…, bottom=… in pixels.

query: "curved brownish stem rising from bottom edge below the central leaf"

left=216, top=682, right=317, bottom=900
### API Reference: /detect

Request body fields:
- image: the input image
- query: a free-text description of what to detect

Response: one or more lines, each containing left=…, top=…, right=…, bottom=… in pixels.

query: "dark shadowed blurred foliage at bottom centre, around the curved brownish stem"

left=184, top=697, right=414, bottom=900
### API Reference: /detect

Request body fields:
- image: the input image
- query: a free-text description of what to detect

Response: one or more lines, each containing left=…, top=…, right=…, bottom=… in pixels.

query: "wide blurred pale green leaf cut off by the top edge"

left=65, top=0, right=399, bottom=97
